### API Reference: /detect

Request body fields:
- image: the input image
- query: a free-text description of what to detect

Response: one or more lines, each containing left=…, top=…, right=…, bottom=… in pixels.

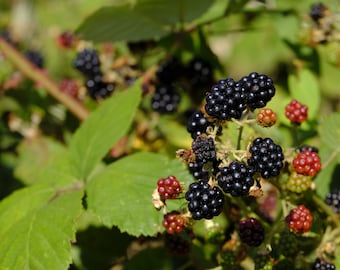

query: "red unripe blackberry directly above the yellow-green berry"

left=293, top=151, right=321, bottom=176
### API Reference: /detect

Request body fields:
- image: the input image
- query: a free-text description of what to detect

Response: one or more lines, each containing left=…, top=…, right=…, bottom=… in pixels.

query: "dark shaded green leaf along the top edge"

left=76, top=0, right=213, bottom=42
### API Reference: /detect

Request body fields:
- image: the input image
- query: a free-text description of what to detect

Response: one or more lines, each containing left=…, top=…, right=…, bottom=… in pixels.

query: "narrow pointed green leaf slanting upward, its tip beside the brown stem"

left=70, top=85, right=141, bottom=179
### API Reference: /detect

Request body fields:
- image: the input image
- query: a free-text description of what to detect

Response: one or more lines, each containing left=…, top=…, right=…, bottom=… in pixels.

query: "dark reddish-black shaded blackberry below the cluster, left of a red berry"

left=238, top=217, right=264, bottom=247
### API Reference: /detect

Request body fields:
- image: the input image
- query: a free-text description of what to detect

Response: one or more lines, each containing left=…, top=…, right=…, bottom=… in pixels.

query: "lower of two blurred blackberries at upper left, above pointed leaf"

left=85, top=76, right=115, bottom=99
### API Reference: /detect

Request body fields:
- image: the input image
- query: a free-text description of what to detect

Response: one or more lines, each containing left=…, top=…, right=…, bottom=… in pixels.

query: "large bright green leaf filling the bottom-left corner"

left=0, top=186, right=83, bottom=270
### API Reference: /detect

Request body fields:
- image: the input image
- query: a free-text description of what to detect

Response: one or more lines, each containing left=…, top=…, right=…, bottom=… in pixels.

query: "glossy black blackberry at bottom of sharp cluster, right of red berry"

left=185, top=180, right=224, bottom=220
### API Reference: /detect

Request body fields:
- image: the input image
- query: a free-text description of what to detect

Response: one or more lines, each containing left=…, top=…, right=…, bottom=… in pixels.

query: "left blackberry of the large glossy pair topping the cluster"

left=205, top=78, right=247, bottom=120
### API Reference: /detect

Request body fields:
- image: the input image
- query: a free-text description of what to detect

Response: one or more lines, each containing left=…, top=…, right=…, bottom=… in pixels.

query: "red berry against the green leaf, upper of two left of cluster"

left=157, top=175, right=182, bottom=200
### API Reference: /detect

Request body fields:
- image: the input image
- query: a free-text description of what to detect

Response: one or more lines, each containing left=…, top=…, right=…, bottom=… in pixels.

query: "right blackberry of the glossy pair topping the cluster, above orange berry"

left=238, top=72, right=275, bottom=110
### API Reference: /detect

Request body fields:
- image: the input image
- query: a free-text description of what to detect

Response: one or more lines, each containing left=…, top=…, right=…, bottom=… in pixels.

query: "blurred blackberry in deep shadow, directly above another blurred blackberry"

left=156, top=57, right=183, bottom=84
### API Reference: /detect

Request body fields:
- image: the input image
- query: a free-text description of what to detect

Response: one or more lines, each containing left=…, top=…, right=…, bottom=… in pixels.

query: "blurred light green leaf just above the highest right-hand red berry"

left=288, top=69, right=321, bottom=120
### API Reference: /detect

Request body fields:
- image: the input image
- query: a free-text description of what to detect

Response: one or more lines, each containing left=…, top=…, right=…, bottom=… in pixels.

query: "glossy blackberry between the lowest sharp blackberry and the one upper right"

left=217, top=161, right=255, bottom=196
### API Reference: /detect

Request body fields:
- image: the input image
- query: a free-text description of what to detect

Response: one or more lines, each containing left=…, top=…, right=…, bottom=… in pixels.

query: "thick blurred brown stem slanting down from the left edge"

left=0, top=38, right=88, bottom=120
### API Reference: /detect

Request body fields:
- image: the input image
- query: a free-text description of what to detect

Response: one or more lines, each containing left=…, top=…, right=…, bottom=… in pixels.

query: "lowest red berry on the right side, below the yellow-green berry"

left=285, top=205, right=313, bottom=234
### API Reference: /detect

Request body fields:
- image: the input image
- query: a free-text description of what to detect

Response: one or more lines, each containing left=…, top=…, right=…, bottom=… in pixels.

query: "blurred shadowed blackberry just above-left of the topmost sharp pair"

left=187, top=57, right=214, bottom=88
